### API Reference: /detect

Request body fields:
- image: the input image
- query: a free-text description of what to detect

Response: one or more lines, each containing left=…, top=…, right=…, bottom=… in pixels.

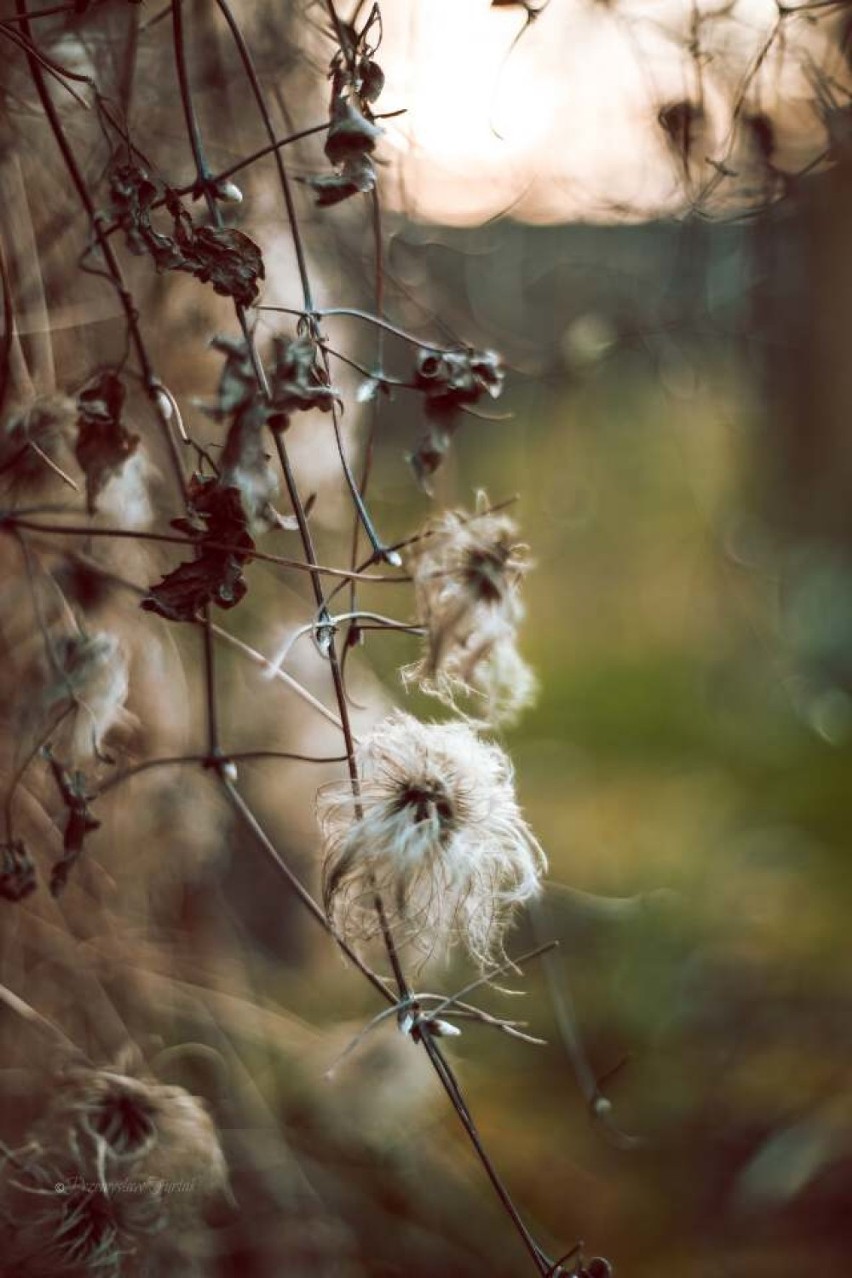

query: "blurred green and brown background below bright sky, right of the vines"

left=310, top=185, right=852, bottom=1278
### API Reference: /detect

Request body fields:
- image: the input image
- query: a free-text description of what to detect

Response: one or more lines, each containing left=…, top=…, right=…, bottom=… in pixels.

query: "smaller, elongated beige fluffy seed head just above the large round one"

left=402, top=493, right=535, bottom=723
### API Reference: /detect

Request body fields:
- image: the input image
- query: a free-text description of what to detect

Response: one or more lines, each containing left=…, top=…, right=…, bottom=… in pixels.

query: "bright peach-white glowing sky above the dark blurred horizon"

left=381, top=0, right=841, bottom=224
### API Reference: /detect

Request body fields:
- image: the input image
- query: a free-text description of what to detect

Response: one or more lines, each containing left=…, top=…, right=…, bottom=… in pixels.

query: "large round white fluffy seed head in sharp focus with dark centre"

left=318, top=711, right=545, bottom=967
